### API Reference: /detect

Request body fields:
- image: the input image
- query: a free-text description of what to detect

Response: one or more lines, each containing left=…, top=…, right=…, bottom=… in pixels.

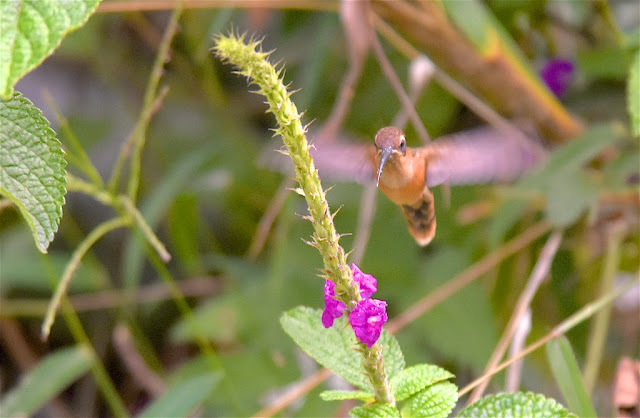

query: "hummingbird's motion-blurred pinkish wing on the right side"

left=425, top=127, right=545, bottom=186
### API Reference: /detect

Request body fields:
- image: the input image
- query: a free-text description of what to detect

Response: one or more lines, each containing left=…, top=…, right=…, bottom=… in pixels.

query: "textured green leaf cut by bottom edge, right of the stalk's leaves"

left=458, top=392, right=576, bottom=418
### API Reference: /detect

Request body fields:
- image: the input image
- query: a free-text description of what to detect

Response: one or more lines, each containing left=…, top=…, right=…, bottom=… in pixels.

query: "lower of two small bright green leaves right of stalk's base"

left=400, top=382, right=458, bottom=418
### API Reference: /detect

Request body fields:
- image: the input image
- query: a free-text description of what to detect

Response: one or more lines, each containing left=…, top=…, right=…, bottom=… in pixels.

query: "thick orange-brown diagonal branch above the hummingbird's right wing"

left=372, top=0, right=582, bottom=141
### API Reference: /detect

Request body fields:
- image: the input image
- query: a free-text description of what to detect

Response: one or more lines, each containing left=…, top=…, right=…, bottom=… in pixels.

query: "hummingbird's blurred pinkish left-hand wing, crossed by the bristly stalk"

left=261, top=142, right=375, bottom=184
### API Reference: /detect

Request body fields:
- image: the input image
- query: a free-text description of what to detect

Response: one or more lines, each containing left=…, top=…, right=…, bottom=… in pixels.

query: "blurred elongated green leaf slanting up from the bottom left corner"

left=0, top=345, right=94, bottom=417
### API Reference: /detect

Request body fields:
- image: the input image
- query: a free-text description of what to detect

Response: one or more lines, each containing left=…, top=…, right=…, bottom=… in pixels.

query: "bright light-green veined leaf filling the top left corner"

left=0, top=0, right=100, bottom=99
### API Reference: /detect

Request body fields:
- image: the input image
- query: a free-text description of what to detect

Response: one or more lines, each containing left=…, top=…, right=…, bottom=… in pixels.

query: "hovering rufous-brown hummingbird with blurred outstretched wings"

left=270, top=126, right=545, bottom=246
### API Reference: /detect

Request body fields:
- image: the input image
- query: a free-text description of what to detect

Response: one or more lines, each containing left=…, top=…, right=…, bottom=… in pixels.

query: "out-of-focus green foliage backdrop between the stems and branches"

left=0, top=0, right=640, bottom=416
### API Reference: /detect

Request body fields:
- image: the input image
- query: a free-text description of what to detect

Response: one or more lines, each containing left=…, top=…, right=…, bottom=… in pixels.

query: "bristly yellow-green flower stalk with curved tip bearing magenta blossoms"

left=214, top=34, right=394, bottom=403
